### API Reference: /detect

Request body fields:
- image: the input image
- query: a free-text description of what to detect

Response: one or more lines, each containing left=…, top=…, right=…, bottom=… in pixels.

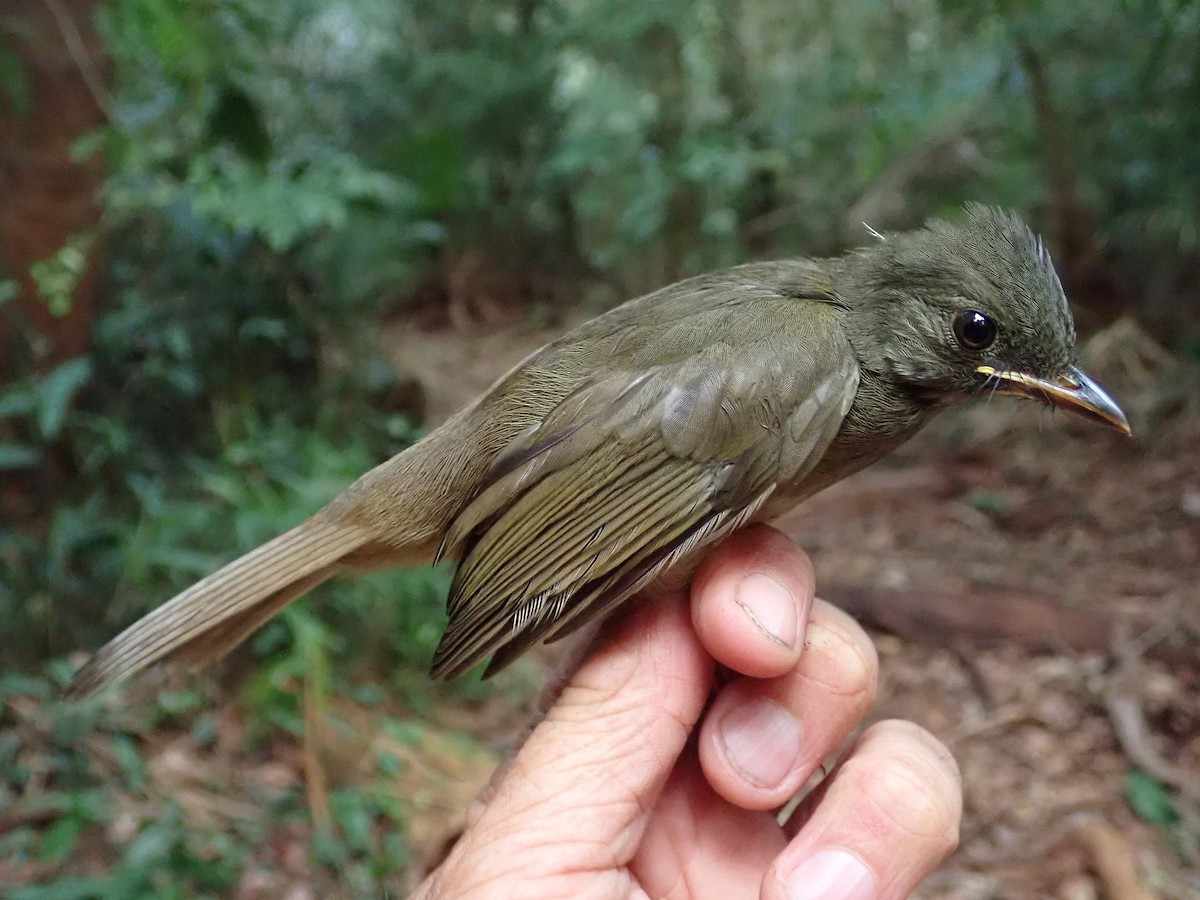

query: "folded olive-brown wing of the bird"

left=433, top=296, right=858, bottom=678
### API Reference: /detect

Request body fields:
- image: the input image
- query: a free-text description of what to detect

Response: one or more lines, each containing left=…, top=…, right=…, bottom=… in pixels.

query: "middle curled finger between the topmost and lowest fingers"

left=700, top=600, right=878, bottom=810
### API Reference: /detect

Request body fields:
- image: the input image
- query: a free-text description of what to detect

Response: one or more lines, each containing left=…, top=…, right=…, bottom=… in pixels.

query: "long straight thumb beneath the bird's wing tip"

left=420, top=599, right=713, bottom=896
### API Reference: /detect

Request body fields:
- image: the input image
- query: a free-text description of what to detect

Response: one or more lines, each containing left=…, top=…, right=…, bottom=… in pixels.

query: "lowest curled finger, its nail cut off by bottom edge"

left=763, top=721, right=962, bottom=900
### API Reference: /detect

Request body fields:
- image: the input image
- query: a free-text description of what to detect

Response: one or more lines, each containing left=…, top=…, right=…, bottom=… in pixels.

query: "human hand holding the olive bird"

left=416, top=526, right=962, bottom=900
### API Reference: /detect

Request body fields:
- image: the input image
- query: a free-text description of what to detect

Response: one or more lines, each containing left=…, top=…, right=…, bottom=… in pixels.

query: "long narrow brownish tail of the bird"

left=67, top=520, right=370, bottom=697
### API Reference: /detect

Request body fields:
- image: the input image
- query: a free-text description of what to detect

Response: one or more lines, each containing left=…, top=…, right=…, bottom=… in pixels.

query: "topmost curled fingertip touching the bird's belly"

left=691, top=524, right=814, bottom=678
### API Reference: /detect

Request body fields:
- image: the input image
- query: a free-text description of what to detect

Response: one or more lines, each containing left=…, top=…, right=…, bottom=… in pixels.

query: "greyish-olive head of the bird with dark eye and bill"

left=842, top=204, right=1129, bottom=434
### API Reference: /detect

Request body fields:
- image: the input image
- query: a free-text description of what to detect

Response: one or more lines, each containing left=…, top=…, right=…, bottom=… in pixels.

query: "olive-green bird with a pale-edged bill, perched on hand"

left=67, top=204, right=1130, bottom=696
